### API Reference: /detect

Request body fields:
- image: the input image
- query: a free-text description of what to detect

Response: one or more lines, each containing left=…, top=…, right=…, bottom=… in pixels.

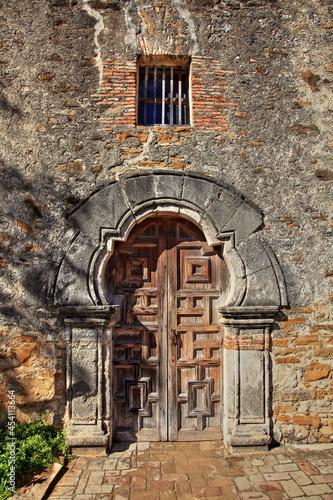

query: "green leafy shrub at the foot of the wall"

left=0, top=418, right=67, bottom=500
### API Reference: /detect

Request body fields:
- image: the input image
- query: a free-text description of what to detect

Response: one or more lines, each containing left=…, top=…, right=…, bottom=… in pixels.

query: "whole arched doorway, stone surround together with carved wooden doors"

left=56, top=171, right=288, bottom=451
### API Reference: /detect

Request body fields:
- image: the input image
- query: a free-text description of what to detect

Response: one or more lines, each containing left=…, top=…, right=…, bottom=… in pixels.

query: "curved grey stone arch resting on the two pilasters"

left=54, top=171, right=287, bottom=306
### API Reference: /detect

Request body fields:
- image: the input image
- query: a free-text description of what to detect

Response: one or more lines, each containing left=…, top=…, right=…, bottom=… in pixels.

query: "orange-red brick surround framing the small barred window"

left=94, top=55, right=233, bottom=133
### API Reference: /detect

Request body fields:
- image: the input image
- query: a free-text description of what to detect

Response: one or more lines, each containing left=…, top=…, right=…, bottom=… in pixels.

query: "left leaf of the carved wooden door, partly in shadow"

left=109, top=224, right=162, bottom=441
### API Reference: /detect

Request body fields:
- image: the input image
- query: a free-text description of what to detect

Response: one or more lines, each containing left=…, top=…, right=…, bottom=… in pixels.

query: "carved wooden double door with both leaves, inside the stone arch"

left=106, top=216, right=228, bottom=441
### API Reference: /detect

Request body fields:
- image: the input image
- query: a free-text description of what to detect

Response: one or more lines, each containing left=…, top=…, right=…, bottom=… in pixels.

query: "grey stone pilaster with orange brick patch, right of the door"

left=219, top=306, right=278, bottom=451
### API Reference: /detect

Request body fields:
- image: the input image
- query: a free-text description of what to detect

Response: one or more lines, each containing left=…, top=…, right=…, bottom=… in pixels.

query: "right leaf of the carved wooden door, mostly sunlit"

left=173, top=224, right=222, bottom=441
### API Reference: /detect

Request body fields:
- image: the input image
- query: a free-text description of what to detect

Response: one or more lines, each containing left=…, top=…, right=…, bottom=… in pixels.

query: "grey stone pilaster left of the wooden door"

left=60, top=306, right=117, bottom=454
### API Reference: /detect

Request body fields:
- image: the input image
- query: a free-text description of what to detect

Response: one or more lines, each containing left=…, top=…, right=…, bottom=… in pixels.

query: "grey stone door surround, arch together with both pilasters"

left=53, top=170, right=287, bottom=450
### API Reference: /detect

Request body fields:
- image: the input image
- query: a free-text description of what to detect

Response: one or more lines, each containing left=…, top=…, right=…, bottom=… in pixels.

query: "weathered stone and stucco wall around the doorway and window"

left=0, top=0, right=333, bottom=442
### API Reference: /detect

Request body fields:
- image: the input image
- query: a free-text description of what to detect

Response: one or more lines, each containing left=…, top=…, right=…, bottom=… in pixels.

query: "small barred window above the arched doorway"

left=138, top=57, right=190, bottom=125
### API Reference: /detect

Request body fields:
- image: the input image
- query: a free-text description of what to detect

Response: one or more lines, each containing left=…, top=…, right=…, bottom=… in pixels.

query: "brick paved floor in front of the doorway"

left=49, top=441, right=333, bottom=500
